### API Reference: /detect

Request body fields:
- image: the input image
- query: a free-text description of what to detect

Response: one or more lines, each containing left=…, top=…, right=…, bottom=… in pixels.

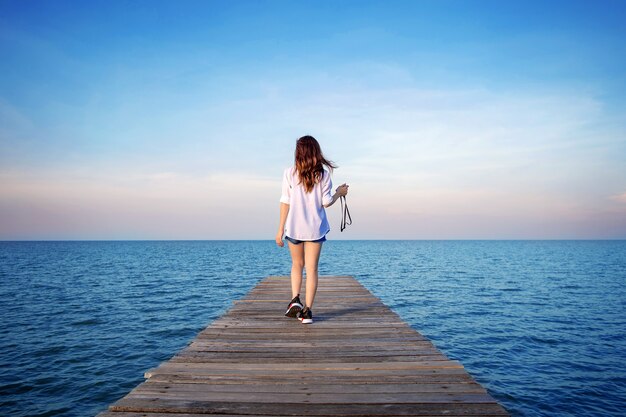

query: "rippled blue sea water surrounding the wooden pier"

left=0, top=240, right=626, bottom=416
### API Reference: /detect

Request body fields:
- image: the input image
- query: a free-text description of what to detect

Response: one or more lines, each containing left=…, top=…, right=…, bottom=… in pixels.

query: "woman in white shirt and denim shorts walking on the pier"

left=276, top=136, right=348, bottom=324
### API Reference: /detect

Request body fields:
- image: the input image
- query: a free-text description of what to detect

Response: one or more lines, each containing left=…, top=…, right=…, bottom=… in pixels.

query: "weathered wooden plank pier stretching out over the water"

left=98, top=276, right=508, bottom=417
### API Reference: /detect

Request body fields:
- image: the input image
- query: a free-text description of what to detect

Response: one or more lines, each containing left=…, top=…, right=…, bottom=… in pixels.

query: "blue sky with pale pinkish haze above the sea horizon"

left=0, top=0, right=626, bottom=239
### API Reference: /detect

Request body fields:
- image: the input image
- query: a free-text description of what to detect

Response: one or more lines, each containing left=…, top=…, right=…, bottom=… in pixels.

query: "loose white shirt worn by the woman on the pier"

left=280, top=166, right=333, bottom=240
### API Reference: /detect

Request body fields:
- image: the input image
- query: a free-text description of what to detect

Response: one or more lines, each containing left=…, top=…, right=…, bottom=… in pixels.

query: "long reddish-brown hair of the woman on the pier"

left=295, top=135, right=337, bottom=193
